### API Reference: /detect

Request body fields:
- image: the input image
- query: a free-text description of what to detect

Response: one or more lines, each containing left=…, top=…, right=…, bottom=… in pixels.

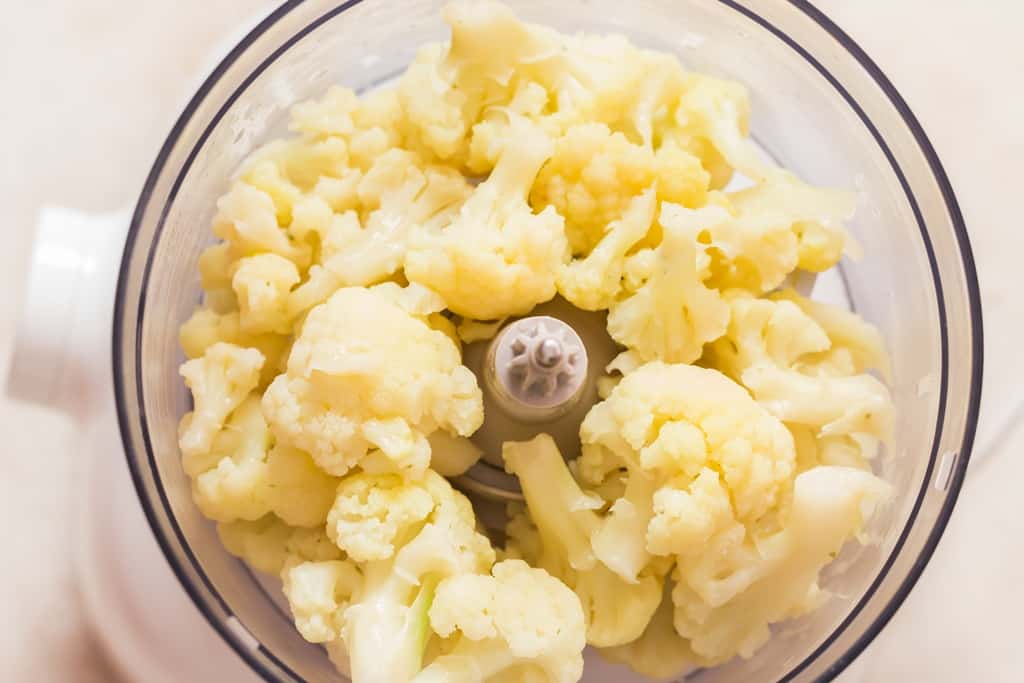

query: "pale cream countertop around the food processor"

left=0, top=0, right=1024, bottom=683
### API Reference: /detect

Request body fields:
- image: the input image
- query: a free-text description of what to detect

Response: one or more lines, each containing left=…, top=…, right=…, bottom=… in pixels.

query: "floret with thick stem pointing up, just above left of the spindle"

left=406, top=121, right=568, bottom=321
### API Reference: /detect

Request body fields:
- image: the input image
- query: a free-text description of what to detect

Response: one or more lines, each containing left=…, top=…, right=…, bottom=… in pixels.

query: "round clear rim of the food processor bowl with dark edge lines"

left=112, top=0, right=984, bottom=683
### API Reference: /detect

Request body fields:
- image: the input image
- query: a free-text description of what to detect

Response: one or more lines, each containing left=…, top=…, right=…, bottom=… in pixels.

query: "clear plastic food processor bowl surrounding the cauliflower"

left=108, top=0, right=982, bottom=681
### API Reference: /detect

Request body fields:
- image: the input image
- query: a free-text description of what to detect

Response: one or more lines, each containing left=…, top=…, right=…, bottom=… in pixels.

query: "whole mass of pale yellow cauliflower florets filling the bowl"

left=179, top=0, right=893, bottom=683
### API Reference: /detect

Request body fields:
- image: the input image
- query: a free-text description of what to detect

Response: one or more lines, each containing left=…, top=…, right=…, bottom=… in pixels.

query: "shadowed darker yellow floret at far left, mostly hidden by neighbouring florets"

left=178, top=308, right=290, bottom=387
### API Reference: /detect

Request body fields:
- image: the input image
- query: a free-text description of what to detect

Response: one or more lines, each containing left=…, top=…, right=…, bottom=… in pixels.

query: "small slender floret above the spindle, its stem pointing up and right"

left=558, top=190, right=655, bottom=310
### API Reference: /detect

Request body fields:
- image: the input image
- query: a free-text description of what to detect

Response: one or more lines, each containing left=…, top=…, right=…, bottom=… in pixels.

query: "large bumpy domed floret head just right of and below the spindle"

left=580, top=361, right=796, bottom=540
